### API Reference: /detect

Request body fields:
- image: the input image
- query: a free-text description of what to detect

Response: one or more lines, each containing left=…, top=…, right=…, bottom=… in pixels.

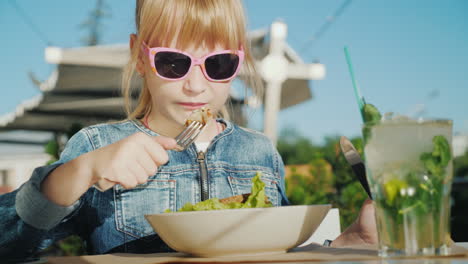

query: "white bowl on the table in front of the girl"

left=145, top=204, right=331, bottom=257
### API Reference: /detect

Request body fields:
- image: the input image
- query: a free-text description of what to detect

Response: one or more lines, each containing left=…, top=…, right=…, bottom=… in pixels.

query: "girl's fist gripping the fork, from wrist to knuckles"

left=87, top=132, right=177, bottom=191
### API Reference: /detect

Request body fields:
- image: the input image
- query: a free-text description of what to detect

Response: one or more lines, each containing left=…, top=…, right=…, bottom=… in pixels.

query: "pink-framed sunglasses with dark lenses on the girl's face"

left=142, top=42, right=244, bottom=82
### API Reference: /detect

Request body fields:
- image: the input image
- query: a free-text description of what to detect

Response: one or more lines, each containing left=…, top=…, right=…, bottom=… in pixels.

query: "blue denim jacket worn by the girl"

left=0, top=119, right=288, bottom=257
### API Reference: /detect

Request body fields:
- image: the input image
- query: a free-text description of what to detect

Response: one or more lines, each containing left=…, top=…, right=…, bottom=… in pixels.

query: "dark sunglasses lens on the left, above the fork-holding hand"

left=154, top=51, right=191, bottom=79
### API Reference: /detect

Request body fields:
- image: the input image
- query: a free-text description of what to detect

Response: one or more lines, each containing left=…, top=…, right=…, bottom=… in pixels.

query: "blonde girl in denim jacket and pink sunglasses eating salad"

left=0, top=0, right=375, bottom=256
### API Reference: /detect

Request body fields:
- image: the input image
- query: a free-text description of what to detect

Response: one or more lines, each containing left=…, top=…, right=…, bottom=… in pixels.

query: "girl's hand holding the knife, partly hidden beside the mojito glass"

left=331, top=199, right=378, bottom=247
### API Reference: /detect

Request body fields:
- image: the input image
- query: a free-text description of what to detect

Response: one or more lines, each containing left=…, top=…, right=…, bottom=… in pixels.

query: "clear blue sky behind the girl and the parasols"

left=0, top=0, right=468, bottom=143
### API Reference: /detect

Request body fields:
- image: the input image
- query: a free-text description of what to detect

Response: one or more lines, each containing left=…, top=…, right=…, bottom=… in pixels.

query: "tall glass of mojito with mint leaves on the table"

left=363, top=109, right=453, bottom=257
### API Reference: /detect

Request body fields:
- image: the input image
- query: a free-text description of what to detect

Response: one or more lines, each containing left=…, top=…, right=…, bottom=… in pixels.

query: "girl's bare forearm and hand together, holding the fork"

left=41, top=133, right=177, bottom=206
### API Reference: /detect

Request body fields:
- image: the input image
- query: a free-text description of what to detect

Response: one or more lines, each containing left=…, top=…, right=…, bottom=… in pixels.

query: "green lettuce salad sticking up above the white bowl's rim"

left=165, top=172, right=273, bottom=213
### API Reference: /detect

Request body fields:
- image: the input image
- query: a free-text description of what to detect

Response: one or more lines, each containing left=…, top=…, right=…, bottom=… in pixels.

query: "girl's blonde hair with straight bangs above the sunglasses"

left=122, top=0, right=263, bottom=119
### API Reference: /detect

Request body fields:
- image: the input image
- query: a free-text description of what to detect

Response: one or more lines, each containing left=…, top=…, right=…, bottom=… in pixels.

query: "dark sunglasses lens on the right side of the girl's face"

left=205, top=54, right=239, bottom=80
